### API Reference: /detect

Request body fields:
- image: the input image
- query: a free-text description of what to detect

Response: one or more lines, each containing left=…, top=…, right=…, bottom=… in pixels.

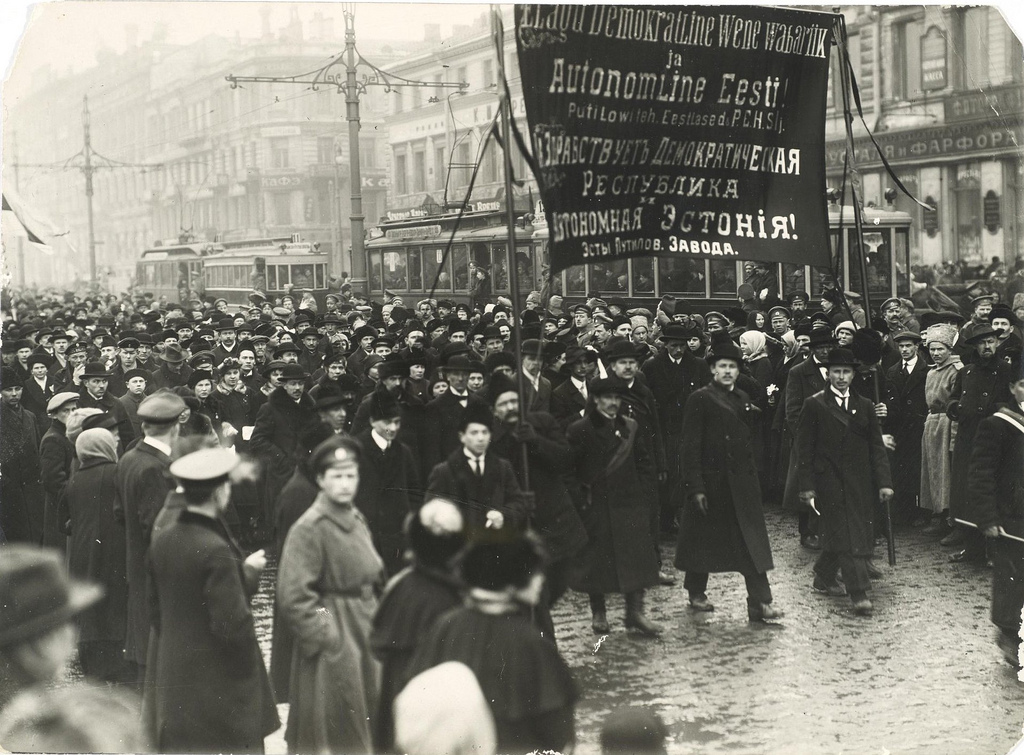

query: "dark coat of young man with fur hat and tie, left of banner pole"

left=423, top=446, right=524, bottom=532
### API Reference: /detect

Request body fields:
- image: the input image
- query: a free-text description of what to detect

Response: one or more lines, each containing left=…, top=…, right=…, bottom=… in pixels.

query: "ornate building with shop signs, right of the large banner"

left=826, top=5, right=1024, bottom=266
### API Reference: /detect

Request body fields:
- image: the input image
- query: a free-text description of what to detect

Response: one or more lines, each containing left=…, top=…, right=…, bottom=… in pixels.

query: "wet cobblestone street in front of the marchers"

left=247, top=510, right=1024, bottom=755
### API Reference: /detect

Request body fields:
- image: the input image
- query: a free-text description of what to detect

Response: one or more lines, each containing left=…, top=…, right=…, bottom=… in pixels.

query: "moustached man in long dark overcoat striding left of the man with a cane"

left=676, top=340, right=782, bottom=621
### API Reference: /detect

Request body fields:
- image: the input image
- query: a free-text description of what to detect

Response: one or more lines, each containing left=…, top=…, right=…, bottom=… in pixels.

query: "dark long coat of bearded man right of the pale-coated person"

left=946, top=352, right=1014, bottom=520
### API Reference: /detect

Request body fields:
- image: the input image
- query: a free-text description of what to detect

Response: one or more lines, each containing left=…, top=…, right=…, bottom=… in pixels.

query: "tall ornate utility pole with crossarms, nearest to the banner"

left=224, top=3, right=469, bottom=280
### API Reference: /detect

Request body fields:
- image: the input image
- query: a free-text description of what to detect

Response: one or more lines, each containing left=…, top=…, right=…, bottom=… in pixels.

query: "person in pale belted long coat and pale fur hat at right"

left=920, top=323, right=957, bottom=536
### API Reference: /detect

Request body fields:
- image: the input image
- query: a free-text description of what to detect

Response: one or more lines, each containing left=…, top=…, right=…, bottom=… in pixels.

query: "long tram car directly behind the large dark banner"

left=366, top=198, right=910, bottom=311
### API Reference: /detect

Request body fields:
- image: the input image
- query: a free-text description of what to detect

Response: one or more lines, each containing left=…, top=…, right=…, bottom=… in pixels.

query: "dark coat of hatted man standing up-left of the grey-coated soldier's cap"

left=249, top=387, right=319, bottom=507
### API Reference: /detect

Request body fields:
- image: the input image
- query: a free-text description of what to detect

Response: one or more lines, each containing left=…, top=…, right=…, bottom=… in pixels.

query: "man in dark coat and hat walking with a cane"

left=791, top=348, right=893, bottom=616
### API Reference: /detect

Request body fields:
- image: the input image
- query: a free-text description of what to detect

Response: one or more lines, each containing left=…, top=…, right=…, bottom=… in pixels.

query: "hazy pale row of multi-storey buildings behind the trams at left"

left=5, top=6, right=415, bottom=288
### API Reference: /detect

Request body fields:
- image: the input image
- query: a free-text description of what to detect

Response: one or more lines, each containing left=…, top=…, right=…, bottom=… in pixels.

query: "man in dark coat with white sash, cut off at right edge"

left=968, top=368, right=1024, bottom=668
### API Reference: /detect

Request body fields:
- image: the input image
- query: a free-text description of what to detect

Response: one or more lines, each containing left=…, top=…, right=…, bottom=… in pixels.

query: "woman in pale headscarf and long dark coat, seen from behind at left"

left=66, top=427, right=128, bottom=682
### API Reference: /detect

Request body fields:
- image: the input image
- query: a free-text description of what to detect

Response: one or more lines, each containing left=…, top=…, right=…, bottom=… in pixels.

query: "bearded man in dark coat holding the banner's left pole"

left=487, top=375, right=587, bottom=639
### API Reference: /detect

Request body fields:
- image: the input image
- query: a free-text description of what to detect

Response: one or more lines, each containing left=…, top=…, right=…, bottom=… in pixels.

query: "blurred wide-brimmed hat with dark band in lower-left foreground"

left=0, top=543, right=103, bottom=647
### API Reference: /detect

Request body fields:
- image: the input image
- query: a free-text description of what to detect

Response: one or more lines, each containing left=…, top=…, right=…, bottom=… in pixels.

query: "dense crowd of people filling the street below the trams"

left=0, top=278, right=1024, bottom=753
